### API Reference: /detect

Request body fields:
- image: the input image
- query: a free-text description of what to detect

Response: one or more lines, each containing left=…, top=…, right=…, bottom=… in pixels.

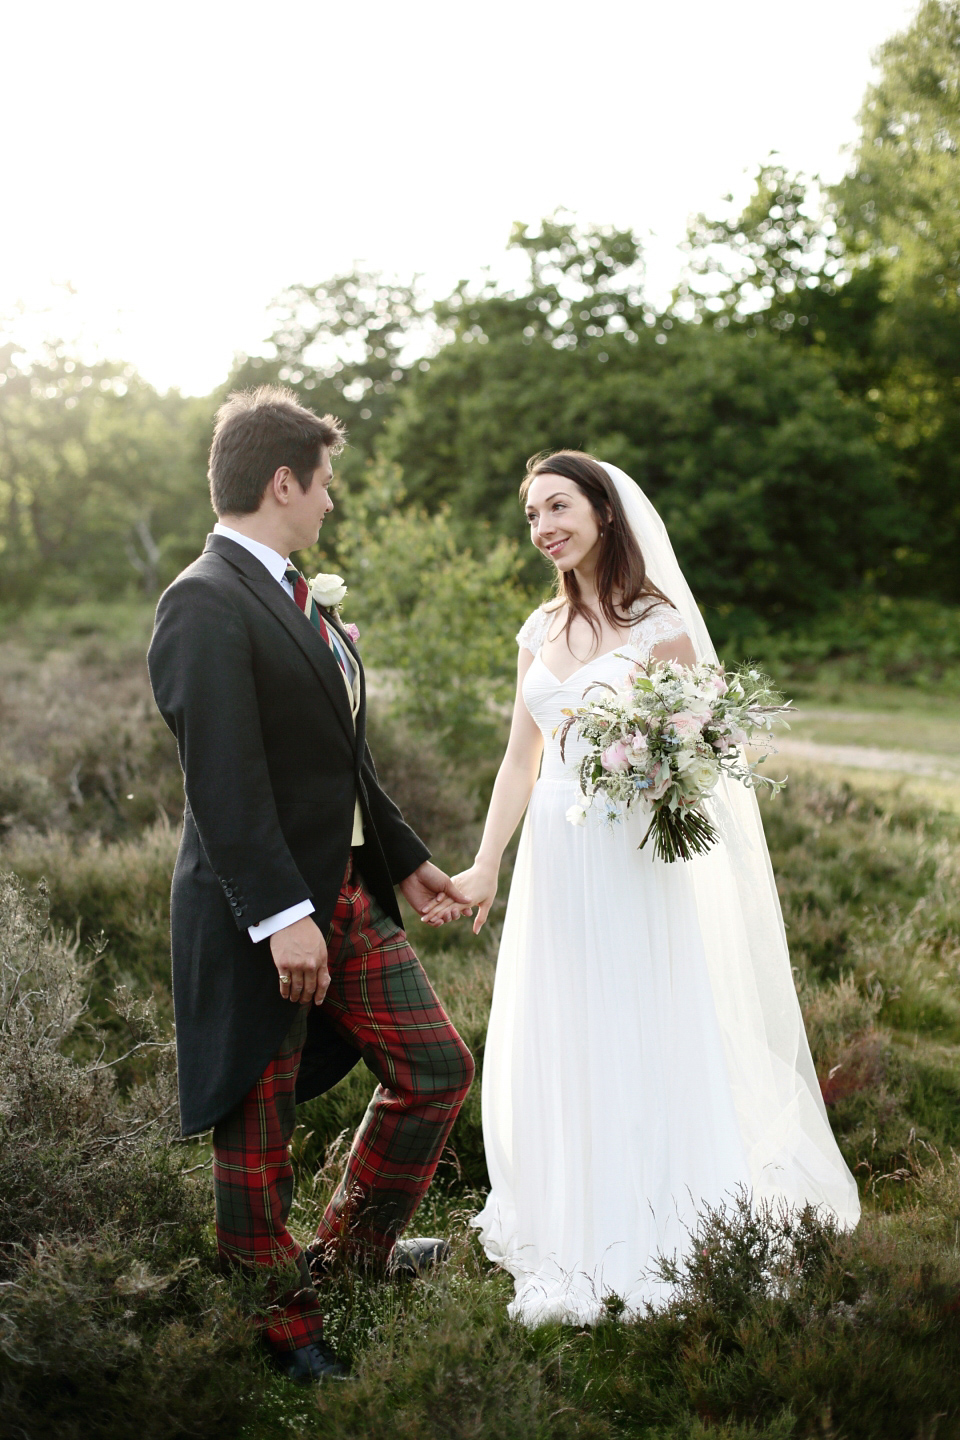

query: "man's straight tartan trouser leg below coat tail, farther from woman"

left=213, top=1007, right=324, bottom=1351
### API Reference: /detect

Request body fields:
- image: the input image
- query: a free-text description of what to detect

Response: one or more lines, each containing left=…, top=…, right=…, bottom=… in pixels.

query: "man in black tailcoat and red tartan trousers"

left=148, top=387, right=474, bottom=1381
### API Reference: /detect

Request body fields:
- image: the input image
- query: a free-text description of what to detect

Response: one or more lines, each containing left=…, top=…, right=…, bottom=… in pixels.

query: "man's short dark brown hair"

left=207, top=384, right=347, bottom=516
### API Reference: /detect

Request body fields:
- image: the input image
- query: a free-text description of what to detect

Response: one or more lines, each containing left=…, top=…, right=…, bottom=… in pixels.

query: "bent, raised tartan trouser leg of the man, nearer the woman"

left=317, top=864, right=474, bottom=1256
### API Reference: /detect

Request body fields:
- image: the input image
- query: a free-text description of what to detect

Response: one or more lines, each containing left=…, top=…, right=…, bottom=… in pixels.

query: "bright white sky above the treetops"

left=0, top=0, right=915, bottom=393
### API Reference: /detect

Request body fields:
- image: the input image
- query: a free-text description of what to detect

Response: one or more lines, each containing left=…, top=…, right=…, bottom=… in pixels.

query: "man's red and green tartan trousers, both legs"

left=213, top=857, right=474, bottom=1351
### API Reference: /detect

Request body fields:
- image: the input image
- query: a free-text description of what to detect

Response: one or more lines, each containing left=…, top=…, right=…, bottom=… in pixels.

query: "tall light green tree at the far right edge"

left=833, top=0, right=960, bottom=602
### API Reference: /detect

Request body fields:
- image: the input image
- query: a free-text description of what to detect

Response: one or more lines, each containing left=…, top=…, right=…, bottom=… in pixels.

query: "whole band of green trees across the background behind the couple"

left=0, top=0, right=960, bottom=625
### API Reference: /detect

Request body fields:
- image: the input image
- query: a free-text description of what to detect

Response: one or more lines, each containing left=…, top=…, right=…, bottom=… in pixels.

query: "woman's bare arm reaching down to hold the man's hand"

left=425, top=648, right=543, bottom=935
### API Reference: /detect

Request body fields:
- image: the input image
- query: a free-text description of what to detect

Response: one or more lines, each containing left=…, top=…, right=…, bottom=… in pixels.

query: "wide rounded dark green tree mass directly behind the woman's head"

left=384, top=312, right=902, bottom=625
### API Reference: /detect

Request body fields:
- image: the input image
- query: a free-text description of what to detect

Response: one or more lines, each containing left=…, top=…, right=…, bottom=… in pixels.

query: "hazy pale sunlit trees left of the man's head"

left=0, top=346, right=210, bottom=603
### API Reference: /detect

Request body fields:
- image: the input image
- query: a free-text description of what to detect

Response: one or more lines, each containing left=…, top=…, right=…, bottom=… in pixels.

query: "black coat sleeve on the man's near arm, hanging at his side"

left=147, top=576, right=312, bottom=930
